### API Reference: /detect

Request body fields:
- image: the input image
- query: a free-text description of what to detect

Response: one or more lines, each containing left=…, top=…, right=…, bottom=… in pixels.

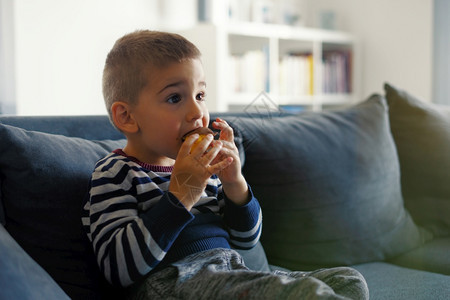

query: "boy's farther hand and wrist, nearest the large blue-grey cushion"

left=212, top=118, right=248, bottom=205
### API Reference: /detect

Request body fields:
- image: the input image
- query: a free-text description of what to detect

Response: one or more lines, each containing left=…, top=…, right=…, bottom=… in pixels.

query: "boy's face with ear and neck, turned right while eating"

left=127, top=59, right=209, bottom=165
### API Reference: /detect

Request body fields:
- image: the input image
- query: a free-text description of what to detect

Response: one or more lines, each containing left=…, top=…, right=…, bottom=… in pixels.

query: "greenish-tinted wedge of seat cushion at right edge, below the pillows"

left=389, top=238, right=450, bottom=276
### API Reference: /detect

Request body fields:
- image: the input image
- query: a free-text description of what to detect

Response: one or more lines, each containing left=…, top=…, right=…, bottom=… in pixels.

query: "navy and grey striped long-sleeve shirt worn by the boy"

left=82, top=150, right=262, bottom=286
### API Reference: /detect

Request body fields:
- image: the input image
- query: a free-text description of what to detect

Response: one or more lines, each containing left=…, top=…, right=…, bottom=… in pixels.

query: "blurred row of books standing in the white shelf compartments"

left=228, top=50, right=352, bottom=96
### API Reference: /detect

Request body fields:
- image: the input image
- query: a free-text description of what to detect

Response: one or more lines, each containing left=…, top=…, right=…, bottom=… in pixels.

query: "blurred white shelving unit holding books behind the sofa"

left=181, top=22, right=359, bottom=111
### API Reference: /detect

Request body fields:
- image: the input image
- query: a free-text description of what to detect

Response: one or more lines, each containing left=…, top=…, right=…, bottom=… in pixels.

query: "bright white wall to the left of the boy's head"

left=14, top=0, right=158, bottom=115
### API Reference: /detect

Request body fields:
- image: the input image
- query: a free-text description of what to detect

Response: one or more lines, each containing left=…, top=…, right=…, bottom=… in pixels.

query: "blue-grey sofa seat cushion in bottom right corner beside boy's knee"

left=353, top=262, right=450, bottom=300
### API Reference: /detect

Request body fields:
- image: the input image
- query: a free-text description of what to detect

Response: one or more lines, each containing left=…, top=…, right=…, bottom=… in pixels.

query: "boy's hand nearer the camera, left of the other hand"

left=169, top=134, right=233, bottom=210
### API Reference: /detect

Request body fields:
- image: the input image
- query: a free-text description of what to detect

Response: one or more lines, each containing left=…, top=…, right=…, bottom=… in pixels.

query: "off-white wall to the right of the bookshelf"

left=307, top=0, right=433, bottom=101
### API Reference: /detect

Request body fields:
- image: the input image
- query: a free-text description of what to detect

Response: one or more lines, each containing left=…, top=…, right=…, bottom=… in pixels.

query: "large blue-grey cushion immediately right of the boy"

left=228, top=95, right=429, bottom=270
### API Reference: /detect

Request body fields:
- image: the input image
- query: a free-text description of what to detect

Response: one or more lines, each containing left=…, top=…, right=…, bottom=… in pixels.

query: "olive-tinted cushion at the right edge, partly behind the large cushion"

left=385, top=84, right=450, bottom=236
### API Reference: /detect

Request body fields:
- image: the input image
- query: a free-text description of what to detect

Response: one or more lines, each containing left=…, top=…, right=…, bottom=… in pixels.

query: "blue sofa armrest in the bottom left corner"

left=0, top=225, right=69, bottom=299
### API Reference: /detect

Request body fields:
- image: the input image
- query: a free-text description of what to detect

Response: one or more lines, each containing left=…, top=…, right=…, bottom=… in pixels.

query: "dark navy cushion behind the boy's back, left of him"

left=0, top=124, right=124, bottom=298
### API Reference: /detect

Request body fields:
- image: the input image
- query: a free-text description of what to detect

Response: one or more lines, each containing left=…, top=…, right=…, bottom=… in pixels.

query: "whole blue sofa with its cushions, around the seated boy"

left=0, top=84, right=450, bottom=299
